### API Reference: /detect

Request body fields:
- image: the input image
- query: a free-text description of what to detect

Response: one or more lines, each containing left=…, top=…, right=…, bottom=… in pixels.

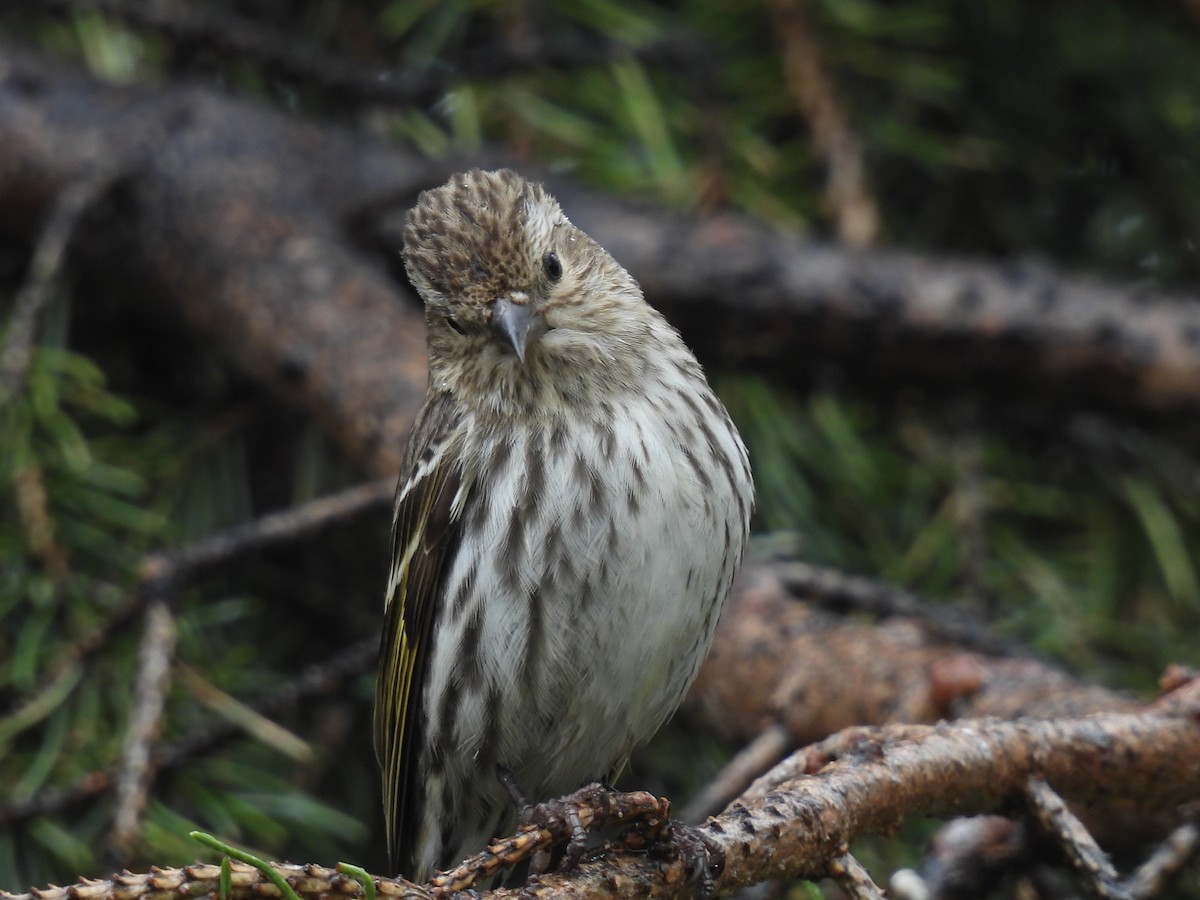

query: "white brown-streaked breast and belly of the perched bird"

left=425, top=381, right=752, bottom=873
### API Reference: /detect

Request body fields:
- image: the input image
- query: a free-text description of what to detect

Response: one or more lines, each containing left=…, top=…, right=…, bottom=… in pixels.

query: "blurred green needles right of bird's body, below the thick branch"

left=721, top=378, right=1200, bottom=690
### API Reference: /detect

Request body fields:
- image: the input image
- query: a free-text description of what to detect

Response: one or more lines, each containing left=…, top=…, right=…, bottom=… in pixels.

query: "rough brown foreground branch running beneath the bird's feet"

left=0, top=682, right=1200, bottom=900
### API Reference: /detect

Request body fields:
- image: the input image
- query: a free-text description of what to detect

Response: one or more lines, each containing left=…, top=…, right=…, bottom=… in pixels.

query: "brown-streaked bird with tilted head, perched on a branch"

left=374, top=169, right=754, bottom=881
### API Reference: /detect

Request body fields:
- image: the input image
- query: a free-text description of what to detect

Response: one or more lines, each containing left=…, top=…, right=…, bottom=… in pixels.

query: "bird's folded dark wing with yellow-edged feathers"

left=374, top=395, right=463, bottom=872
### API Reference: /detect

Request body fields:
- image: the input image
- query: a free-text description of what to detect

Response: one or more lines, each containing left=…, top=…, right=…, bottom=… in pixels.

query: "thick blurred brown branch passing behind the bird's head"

left=7, top=49, right=1200, bottom=460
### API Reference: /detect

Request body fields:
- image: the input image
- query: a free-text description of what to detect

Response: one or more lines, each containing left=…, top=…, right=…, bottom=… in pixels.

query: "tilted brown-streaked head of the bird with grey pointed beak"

left=404, top=169, right=653, bottom=415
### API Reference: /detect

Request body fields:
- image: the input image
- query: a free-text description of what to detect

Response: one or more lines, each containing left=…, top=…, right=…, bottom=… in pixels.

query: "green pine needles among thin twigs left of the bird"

left=0, top=290, right=373, bottom=888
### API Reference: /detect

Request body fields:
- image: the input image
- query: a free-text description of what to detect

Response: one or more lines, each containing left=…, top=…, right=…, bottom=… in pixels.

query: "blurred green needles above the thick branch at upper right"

left=374, top=0, right=1200, bottom=284
